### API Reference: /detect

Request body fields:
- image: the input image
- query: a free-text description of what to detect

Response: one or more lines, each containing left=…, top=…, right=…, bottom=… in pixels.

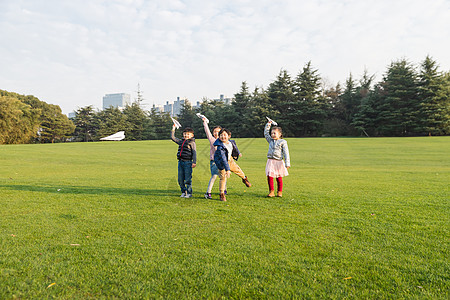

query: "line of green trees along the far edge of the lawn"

left=0, top=56, right=450, bottom=143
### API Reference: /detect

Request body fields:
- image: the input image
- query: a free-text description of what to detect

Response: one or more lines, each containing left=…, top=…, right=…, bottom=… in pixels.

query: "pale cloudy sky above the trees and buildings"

left=0, top=0, right=450, bottom=114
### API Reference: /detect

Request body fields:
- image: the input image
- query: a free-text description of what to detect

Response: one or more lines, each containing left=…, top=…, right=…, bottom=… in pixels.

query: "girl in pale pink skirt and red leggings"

left=264, top=121, right=291, bottom=197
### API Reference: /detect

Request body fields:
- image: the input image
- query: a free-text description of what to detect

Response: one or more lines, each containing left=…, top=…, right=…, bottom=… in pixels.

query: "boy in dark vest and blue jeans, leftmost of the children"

left=171, top=125, right=197, bottom=198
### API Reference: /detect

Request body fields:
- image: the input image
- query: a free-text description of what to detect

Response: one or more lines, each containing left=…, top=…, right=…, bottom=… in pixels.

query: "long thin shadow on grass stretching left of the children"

left=0, top=184, right=180, bottom=197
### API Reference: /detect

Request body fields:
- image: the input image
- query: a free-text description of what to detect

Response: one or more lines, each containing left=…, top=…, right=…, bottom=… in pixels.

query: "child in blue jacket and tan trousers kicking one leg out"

left=214, top=128, right=252, bottom=201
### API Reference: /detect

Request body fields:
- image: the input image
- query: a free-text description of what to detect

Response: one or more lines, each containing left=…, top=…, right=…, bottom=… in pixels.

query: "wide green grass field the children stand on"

left=0, top=137, right=450, bottom=299
